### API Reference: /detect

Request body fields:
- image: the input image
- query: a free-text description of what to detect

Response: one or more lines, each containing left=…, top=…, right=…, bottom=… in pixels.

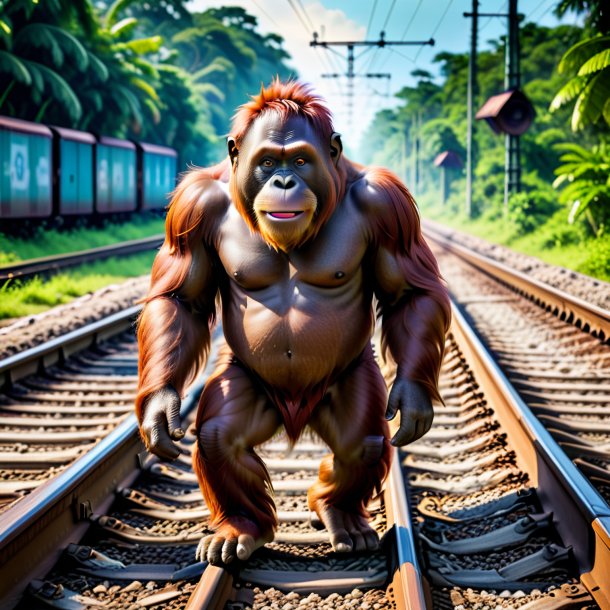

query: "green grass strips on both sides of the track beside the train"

left=0, top=216, right=164, bottom=320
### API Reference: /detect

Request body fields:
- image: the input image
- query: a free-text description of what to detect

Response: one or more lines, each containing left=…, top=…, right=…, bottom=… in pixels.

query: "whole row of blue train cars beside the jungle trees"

left=0, top=116, right=177, bottom=221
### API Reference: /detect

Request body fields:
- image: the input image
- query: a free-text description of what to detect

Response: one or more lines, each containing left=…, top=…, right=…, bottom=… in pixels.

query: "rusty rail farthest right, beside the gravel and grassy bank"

left=424, top=222, right=610, bottom=341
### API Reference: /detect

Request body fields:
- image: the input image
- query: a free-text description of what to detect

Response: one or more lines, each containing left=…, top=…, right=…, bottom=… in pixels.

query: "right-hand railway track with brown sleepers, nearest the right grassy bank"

left=428, top=222, right=610, bottom=508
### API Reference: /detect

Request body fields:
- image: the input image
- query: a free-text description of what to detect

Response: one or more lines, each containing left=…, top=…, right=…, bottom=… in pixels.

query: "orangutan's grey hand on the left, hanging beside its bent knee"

left=140, top=386, right=184, bottom=460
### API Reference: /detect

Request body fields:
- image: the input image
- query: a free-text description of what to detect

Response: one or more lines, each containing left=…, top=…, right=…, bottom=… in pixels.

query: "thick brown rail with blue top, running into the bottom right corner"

left=451, top=304, right=610, bottom=608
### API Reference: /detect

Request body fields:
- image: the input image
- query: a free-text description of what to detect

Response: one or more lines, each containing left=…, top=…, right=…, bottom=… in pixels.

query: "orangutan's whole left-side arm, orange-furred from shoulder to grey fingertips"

left=136, top=171, right=225, bottom=459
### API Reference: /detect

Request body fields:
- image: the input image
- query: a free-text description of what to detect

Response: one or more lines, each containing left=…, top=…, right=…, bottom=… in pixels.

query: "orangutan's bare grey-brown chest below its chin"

left=218, top=211, right=366, bottom=291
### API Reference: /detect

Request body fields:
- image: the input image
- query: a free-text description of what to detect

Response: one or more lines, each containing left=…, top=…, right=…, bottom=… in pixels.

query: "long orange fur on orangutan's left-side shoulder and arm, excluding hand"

left=135, top=164, right=226, bottom=421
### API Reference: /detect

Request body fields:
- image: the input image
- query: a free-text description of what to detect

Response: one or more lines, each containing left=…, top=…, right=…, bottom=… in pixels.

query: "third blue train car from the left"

left=95, top=136, right=137, bottom=214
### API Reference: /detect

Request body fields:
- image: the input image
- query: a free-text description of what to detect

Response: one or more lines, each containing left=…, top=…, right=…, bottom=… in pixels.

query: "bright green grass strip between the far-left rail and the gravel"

left=0, top=252, right=155, bottom=320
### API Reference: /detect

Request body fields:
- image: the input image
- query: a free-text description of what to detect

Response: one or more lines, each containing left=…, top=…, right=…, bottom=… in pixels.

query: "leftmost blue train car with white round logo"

left=0, top=117, right=53, bottom=220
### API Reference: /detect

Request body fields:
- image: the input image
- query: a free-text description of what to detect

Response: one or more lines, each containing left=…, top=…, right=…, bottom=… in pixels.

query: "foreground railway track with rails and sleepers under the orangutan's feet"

left=0, top=298, right=610, bottom=610
